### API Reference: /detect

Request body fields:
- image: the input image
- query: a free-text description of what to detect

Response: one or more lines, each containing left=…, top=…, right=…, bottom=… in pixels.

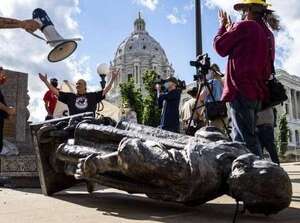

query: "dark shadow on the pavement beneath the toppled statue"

left=54, top=192, right=300, bottom=223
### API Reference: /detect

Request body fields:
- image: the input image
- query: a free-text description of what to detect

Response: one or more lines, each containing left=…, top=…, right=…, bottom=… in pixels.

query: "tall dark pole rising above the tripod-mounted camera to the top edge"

left=195, top=0, right=203, bottom=57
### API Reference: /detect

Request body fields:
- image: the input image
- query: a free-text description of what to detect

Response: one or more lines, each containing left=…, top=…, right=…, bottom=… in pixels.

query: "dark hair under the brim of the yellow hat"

left=249, top=4, right=281, bottom=31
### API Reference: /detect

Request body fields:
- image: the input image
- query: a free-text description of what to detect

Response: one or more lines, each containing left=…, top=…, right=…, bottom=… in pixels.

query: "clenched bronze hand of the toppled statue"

left=75, top=154, right=98, bottom=179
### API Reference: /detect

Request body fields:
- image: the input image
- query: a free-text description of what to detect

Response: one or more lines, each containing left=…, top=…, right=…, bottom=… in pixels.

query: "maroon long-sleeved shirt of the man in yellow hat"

left=214, top=21, right=275, bottom=101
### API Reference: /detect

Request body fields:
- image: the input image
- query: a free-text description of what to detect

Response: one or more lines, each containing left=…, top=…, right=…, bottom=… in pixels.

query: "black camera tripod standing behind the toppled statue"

left=186, top=67, right=231, bottom=139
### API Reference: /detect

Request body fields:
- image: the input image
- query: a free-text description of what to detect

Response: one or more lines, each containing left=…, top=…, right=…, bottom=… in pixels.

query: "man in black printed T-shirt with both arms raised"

left=39, top=70, right=119, bottom=115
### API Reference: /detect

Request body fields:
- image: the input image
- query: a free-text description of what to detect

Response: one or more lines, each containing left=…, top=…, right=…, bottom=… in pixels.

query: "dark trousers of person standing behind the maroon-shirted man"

left=257, top=125, right=279, bottom=164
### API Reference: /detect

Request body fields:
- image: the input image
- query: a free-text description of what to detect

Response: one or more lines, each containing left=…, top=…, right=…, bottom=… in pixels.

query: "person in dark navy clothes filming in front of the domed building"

left=156, top=77, right=181, bottom=133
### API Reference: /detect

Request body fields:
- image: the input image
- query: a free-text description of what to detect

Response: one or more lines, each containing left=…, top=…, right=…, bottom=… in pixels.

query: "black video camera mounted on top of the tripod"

left=190, top=53, right=211, bottom=81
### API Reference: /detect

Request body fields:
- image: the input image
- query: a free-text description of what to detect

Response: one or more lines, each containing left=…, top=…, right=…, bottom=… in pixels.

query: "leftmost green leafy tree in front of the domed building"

left=120, top=78, right=143, bottom=123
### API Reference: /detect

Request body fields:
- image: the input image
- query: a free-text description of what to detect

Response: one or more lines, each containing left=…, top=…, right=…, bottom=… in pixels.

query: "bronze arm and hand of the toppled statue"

left=77, top=138, right=190, bottom=186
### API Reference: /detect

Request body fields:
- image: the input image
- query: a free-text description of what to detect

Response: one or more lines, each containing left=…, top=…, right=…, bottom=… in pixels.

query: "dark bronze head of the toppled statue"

left=228, top=154, right=292, bottom=215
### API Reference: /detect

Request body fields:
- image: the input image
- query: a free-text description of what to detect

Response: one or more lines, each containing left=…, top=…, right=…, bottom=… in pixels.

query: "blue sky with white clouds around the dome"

left=0, top=0, right=300, bottom=120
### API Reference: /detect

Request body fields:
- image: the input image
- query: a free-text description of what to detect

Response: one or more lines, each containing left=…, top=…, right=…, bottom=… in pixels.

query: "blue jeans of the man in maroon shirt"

left=230, top=96, right=262, bottom=157
